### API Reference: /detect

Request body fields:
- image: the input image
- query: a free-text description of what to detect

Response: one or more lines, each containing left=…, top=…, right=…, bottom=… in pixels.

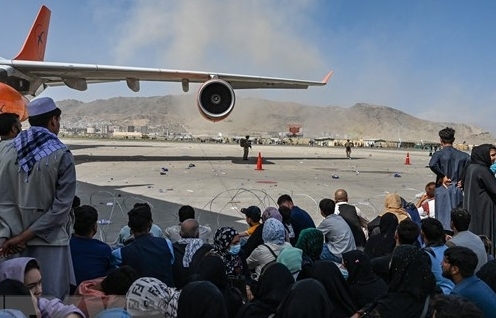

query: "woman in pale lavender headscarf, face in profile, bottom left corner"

left=0, top=257, right=85, bottom=318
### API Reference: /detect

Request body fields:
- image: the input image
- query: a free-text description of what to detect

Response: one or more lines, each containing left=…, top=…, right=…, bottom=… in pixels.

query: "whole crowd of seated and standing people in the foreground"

left=0, top=98, right=496, bottom=318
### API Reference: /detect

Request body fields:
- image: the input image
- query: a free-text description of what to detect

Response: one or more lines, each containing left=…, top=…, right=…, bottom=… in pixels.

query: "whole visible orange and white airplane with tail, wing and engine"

left=0, top=6, right=332, bottom=122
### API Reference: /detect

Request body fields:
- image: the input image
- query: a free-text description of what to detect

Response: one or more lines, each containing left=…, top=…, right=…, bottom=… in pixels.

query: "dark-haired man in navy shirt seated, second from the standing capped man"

left=112, top=204, right=174, bottom=286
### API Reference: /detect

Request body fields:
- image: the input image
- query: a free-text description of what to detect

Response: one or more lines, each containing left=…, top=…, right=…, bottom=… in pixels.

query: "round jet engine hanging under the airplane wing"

left=197, top=78, right=236, bottom=122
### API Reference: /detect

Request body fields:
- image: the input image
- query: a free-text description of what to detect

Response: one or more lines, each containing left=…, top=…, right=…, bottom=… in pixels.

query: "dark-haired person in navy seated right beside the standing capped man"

left=70, top=205, right=113, bottom=285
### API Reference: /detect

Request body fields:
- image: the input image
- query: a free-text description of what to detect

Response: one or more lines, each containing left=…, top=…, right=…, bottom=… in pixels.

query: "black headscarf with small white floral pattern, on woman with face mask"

left=213, top=226, right=243, bottom=275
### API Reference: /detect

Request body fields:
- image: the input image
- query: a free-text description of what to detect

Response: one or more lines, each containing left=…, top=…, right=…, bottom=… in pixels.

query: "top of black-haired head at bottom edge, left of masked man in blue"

left=433, top=294, right=484, bottom=318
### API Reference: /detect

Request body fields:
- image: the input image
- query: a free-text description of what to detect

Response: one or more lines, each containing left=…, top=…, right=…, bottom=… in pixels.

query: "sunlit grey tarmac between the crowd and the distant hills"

left=67, top=138, right=442, bottom=243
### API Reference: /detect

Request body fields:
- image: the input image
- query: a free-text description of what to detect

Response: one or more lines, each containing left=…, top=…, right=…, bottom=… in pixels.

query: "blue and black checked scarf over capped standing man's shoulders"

left=14, top=126, right=67, bottom=176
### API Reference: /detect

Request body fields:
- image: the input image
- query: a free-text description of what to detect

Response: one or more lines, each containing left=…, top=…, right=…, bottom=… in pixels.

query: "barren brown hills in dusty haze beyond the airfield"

left=57, top=94, right=495, bottom=144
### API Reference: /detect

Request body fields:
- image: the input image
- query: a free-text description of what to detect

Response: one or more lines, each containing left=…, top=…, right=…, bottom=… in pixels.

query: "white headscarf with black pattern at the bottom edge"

left=126, top=277, right=180, bottom=318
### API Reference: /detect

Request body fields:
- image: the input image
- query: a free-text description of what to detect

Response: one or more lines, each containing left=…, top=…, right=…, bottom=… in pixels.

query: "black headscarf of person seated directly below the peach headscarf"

left=365, top=213, right=398, bottom=259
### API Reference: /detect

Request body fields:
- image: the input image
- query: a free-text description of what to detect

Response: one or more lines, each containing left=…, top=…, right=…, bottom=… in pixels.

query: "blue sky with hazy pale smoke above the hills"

left=0, top=0, right=496, bottom=135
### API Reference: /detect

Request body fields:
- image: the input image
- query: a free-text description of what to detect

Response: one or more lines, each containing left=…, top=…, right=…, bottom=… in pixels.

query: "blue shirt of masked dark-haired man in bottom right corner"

left=451, top=275, right=496, bottom=318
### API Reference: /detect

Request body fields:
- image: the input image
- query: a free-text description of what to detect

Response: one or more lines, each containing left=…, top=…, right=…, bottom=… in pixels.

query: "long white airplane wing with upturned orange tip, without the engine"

left=4, top=60, right=332, bottom=91
